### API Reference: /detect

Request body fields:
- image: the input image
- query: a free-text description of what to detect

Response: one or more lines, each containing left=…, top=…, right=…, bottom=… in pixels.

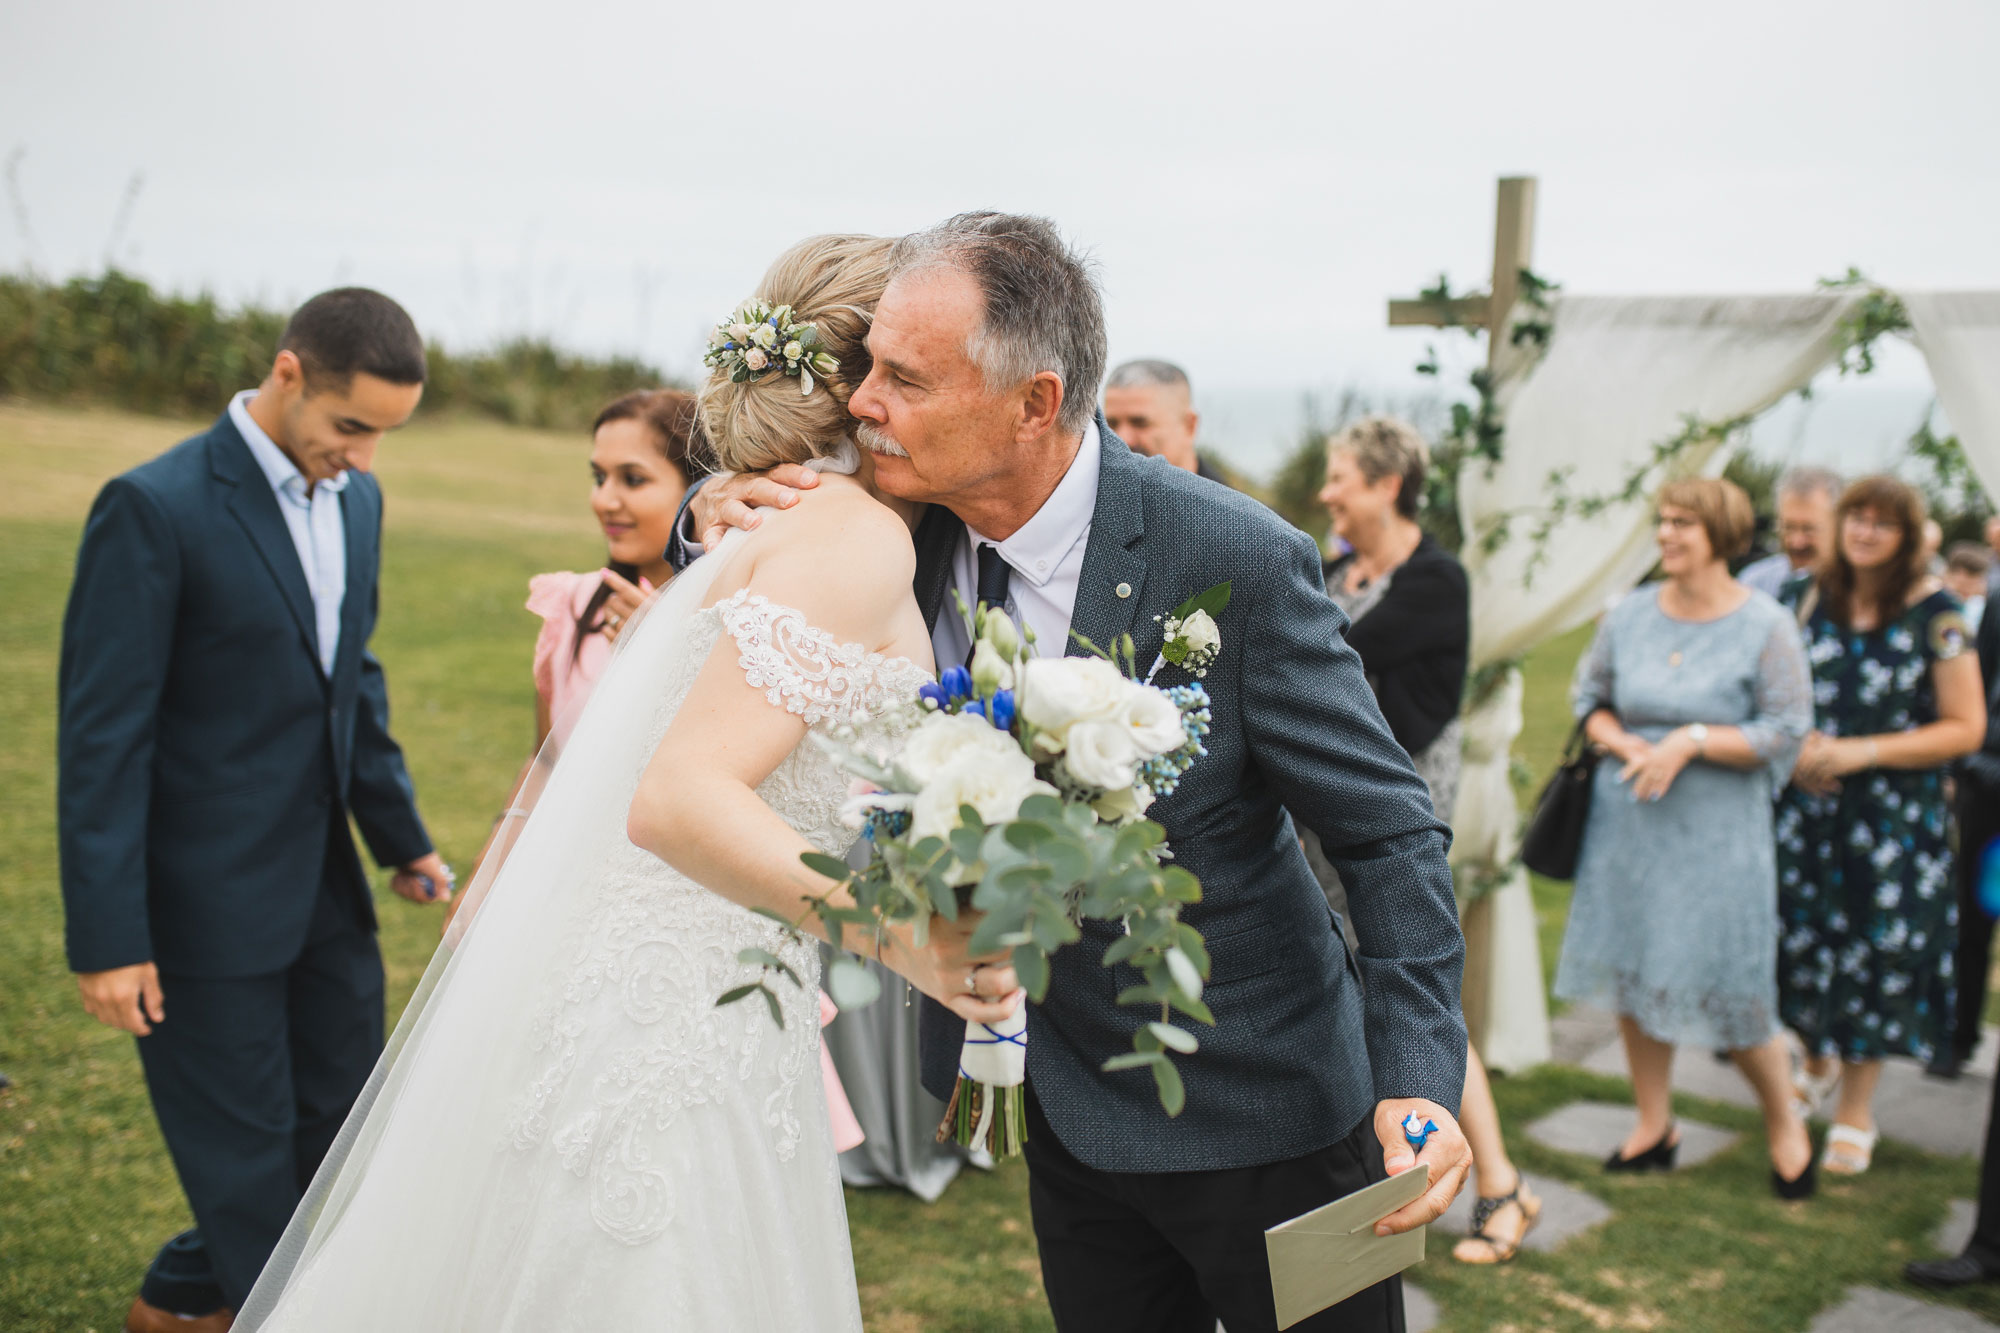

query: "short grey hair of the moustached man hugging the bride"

left=890, top=212, right=1106, bottom=432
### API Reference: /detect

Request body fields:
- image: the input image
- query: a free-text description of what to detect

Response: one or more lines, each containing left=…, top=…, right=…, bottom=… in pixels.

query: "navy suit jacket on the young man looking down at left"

left=56, top=412, right=430, bottom=977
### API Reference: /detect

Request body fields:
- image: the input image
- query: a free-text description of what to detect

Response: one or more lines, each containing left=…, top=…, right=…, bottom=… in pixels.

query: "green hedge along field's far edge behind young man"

left=0, top=268, right=666, bottom=430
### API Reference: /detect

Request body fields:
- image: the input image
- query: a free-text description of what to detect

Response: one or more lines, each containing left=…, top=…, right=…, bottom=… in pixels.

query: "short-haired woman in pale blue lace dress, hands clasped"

left=1556, top=480, right=1814, bottom=1199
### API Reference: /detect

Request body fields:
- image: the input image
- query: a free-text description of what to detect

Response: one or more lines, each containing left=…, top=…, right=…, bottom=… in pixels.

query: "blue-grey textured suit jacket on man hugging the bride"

left=670, top=414, right=1466, bottom=1171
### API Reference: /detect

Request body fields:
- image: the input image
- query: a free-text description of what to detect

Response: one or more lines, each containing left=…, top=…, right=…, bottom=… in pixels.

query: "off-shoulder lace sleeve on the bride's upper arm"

left=716, top=588, right=924, bottom=727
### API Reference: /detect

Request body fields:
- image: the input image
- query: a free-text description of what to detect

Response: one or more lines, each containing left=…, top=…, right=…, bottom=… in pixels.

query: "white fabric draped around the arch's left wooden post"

left=1452, top=292, right=1856, bottom=1069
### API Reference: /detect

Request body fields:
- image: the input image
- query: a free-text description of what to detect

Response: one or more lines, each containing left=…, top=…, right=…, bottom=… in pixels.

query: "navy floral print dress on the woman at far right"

left=1778, top=578, right=1970, bottom=1061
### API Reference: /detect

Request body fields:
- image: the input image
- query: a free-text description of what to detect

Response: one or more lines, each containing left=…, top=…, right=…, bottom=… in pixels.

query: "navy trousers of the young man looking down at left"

left=138, top=829, right=384, bottom=1311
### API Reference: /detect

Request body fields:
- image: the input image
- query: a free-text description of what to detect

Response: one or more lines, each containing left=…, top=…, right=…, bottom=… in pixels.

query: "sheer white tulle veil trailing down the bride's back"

left=234, top=444, right=856, bottom=1333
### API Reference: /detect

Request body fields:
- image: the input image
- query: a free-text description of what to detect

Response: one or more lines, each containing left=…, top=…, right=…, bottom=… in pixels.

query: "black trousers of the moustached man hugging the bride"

left=1022, top=1085, right=1404, bottom=1333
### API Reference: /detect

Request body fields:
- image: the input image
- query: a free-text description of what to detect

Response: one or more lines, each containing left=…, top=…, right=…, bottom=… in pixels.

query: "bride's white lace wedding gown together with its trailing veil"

left=236, top=510, right=928, bottom=1333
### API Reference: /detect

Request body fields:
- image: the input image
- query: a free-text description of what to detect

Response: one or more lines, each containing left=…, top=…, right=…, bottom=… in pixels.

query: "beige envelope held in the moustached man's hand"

left=1264, top=1161, right=1430, bottom=1329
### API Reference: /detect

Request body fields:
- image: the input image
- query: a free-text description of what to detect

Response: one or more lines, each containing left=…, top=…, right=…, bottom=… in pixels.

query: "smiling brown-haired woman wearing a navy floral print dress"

left=1778, top=476, right=1986, bottom=1175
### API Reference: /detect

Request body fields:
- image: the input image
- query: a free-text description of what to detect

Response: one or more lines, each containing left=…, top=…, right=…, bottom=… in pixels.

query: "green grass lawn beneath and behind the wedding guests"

left=0, top=402, right=2000, bottom=1333
